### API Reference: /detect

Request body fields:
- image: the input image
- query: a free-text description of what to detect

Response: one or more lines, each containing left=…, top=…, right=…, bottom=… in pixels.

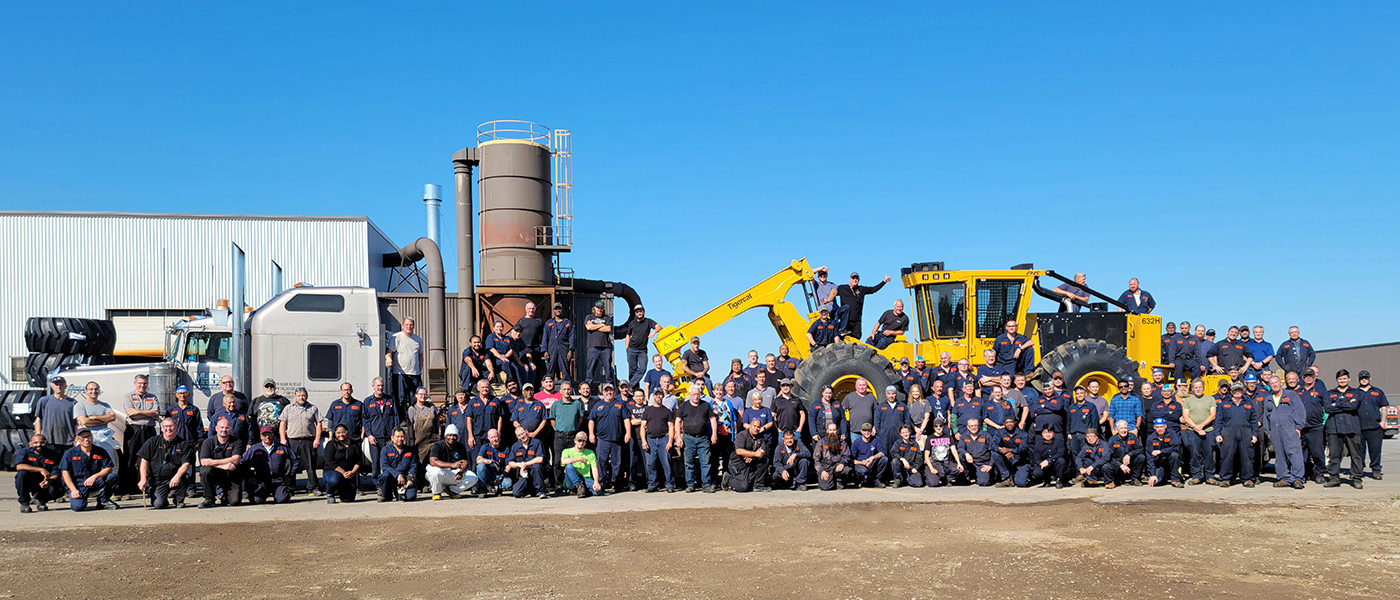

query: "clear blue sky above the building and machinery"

left=0, top=3, right=1400, bottom=361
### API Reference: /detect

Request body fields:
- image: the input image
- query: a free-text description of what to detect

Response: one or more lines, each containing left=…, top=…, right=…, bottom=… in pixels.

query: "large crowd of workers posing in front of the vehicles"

left=15, top=302, right=1389, bottom=512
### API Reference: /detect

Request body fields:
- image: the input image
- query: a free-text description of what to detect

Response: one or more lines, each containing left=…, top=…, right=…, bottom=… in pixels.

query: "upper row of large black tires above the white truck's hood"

left=24, top=316, right=116, bottom=387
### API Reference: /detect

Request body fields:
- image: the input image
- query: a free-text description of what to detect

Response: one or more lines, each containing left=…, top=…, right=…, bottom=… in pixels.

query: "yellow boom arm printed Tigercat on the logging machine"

left=655, top=259, right=813, bottom=383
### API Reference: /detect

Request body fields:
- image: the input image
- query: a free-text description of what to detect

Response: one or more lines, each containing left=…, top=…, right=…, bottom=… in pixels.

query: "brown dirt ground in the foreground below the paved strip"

left=0, top=499, right=1400, bottom=599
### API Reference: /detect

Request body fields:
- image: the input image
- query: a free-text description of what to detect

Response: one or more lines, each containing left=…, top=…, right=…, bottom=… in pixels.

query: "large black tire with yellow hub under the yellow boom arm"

left=792, top=343, right=899, bottom=406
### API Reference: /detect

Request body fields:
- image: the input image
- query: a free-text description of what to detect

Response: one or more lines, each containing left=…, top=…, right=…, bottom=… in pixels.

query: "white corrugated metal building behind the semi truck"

left=0, top=211, right=398, bottom=387
